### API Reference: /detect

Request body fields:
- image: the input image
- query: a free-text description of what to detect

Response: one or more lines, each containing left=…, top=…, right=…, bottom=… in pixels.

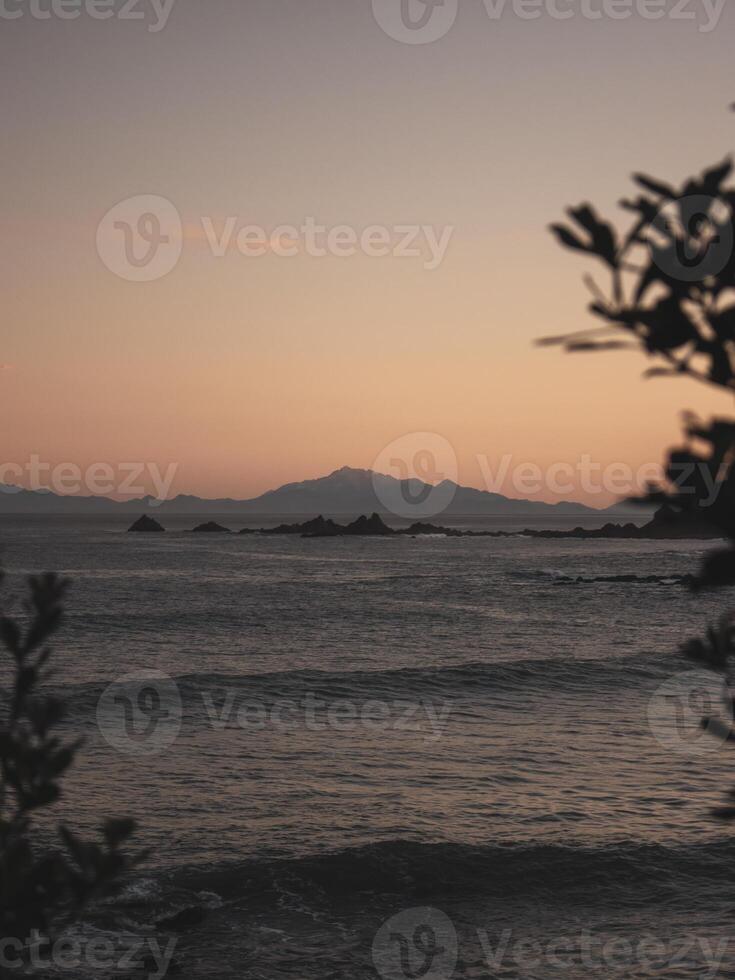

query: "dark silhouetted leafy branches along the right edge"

left=540, top=128, right=735, bottom=820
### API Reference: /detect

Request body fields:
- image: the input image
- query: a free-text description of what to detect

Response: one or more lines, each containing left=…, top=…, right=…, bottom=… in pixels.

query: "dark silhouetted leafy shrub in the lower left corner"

left=0, top=574, right=134, bottom=942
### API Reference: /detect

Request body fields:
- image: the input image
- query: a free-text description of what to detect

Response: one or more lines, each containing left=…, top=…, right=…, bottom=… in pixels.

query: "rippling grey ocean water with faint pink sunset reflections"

left=0, top=517, right=735, bottom=980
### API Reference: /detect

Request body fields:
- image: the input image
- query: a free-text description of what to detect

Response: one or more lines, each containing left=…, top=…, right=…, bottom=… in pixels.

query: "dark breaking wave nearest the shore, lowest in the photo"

left=162, top=840, right=735, bottom=906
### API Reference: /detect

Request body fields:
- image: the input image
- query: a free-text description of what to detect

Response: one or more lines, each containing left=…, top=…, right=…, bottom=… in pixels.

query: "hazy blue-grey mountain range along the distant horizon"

left=0, top=466, right=640, bottom=517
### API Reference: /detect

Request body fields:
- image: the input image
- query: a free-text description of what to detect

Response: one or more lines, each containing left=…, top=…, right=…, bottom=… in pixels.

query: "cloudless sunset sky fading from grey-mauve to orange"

left=0, top=0, right=735, bottom=506
